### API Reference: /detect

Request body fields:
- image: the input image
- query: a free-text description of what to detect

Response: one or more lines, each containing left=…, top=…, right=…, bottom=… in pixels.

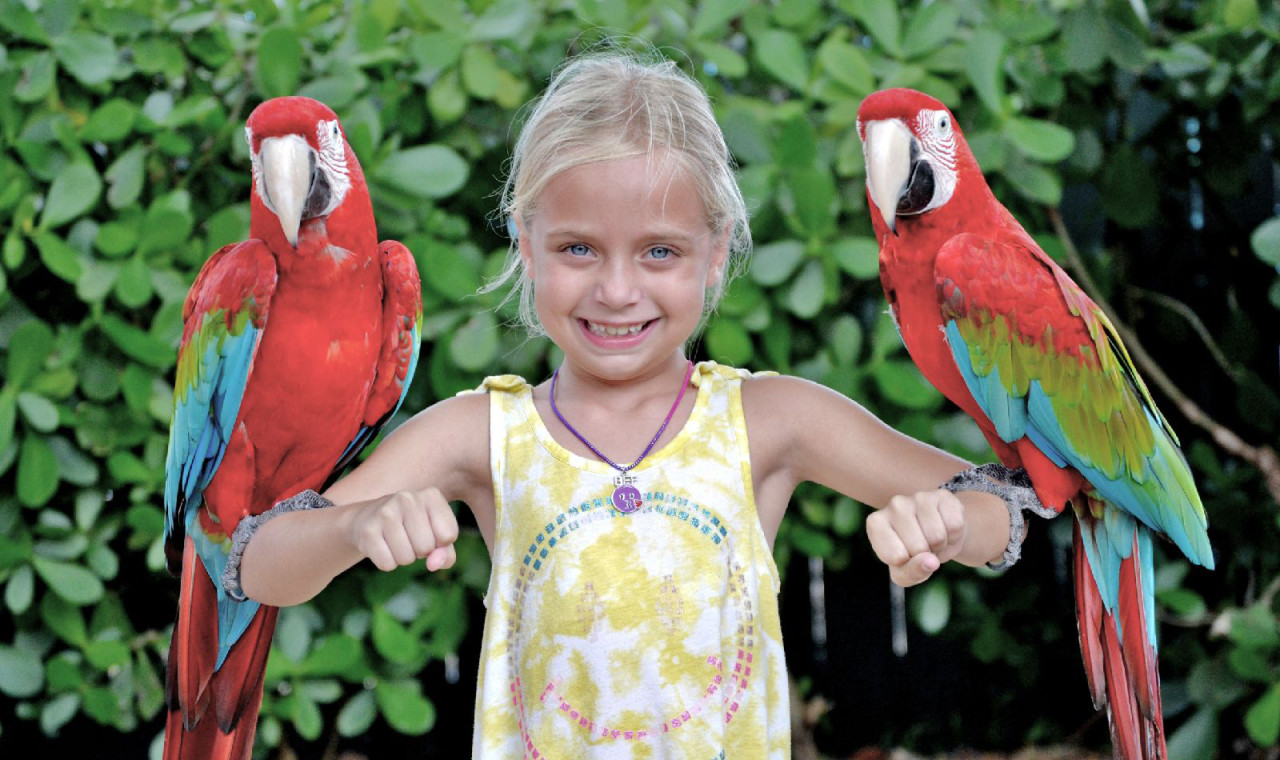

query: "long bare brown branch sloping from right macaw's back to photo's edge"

left=1048, top=207, right=1280, bottom=504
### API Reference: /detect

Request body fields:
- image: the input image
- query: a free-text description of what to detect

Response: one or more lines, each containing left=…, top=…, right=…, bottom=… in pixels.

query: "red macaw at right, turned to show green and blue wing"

left=858, top=90, right=1213, bottom=760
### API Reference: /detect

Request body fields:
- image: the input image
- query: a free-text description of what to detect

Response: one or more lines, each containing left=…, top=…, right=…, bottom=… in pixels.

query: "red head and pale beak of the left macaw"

left=244, top=97, right=360, bottom=246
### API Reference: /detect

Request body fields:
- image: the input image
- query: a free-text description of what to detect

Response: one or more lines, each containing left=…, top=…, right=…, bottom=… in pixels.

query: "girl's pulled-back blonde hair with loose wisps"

left=481, top=44, right=751, bottom=335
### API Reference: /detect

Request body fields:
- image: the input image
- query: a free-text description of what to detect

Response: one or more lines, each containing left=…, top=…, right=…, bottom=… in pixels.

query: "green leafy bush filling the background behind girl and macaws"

left=0, top=0, right=1280, bottom=757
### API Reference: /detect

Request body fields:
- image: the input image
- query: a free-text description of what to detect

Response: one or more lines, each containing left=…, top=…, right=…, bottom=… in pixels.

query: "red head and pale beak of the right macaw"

left=858, top=88, right=986, bottom=234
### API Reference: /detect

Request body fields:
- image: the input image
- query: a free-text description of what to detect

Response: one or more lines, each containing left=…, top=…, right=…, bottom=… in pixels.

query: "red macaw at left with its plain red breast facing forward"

left=164, top=97, right=422, bottom=760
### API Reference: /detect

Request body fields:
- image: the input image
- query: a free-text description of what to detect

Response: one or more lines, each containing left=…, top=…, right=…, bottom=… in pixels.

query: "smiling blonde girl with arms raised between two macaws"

left=229, top=55, right=1020, bottom=760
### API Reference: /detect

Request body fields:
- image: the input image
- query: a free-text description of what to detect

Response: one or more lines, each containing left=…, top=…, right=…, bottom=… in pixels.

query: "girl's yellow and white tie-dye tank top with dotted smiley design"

left=472, top=362, right=791, bottom=760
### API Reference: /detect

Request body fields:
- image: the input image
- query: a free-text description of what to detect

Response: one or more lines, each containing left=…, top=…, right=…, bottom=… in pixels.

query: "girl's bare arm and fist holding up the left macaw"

left=241, top=394, right=493, bottom=606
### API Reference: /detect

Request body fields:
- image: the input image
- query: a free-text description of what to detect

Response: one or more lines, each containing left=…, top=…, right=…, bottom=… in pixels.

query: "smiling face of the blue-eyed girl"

left=520, top=155, right=727, bottom=381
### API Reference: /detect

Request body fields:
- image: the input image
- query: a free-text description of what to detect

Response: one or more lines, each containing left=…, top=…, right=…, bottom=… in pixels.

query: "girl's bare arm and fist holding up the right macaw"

left=742, top=376, right=1009, bottom=585
